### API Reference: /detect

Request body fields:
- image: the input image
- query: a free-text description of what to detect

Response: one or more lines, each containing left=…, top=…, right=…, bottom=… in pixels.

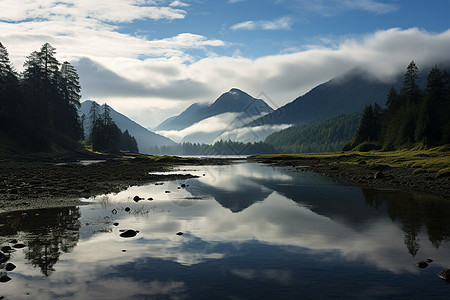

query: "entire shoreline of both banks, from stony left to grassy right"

left=0, top=149, right=450, bottom=214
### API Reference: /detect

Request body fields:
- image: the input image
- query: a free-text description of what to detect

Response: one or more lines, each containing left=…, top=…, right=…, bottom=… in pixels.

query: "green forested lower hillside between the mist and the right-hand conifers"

left=264, top=113, right=360, bottom=153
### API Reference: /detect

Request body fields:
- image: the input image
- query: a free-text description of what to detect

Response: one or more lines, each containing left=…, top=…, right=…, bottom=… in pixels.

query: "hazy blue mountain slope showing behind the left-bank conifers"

left=78, top=100, right=175, bottom=153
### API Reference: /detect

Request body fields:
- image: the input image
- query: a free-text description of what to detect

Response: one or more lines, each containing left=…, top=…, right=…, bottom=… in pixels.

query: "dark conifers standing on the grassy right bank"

left=343, top=61, right=450, bottom=150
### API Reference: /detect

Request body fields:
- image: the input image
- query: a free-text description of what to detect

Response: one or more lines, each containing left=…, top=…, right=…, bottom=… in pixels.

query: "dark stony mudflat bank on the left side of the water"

left=0, top=155, right=228, bottom=213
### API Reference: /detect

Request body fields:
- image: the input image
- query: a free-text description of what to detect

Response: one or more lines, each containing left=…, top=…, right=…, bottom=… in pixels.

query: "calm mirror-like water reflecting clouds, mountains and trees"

left=0, top=163, right=450, bottom=299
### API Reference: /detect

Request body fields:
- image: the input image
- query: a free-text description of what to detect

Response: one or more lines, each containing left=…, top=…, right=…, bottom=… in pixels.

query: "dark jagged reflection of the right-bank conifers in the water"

left=362, top=189, right=450, bottom=256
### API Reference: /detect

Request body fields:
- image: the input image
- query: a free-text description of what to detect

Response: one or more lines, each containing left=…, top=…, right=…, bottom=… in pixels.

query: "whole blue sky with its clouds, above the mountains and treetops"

left=0, top=0, right=450, bottom=127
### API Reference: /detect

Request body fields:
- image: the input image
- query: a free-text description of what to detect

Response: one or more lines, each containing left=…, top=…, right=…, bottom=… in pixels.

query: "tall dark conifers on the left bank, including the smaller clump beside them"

left=0, top=43, right=138, bottom=152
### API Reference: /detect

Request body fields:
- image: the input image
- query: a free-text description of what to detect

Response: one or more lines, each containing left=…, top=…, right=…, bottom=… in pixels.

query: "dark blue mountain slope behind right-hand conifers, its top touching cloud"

left=247, top=69, right=402, bottom=126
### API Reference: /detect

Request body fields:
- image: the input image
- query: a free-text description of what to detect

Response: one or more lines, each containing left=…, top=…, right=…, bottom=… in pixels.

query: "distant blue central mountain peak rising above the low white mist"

left=155, top=88, right=273, bottom=131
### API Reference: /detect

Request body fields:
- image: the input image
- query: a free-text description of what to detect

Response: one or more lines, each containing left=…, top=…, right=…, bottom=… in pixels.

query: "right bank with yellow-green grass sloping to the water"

left=248, top=146, right=450, bottom=200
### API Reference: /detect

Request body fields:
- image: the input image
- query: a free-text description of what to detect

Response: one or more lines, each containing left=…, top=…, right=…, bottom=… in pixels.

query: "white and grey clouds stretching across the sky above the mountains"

left=0, top=0, right=450, bottom=132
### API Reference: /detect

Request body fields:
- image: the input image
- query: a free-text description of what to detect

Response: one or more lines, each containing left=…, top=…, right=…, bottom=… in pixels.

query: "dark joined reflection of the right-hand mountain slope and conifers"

left=253, top=171, right=450, bottom=256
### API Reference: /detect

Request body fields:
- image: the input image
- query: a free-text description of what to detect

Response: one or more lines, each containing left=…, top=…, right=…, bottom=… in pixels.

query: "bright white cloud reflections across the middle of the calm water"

left=82, top=164, right=450, bottom=273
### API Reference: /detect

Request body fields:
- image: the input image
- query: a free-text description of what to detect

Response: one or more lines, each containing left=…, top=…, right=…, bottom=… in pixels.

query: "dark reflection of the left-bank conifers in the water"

left=0, top=207, right=80, bottom=276
